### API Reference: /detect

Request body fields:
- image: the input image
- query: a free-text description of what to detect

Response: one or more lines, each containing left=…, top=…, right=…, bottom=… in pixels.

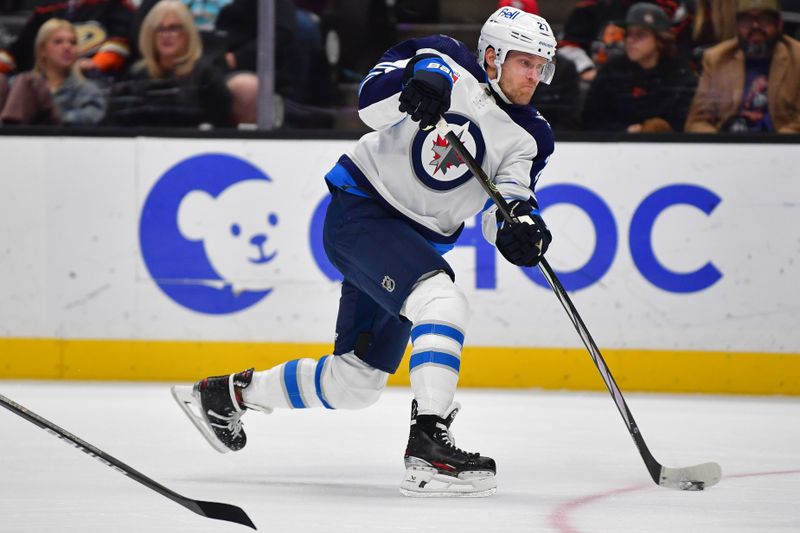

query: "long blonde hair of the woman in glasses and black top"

left=139, top=0, right=203, bottom=78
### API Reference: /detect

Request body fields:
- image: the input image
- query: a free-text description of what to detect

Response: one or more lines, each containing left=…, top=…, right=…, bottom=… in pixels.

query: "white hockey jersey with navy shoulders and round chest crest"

left=326, top=35, right=554, bottom=248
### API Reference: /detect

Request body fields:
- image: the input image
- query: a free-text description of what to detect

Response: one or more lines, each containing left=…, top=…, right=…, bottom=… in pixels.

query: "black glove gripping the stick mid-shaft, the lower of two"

left=495, top=200, right=553, bottom=266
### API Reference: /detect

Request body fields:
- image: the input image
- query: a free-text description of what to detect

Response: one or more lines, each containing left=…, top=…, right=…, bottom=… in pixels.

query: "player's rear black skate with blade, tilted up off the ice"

left=172, top=368, right=253, bottom=453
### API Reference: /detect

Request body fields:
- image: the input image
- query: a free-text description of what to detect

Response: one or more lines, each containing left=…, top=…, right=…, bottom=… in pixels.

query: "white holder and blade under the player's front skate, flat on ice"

left=400, top=467, right=497, bottom=498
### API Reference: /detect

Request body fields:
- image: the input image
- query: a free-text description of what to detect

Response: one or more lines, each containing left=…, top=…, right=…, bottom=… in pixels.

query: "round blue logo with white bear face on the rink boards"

left=139, top=154, right=281, bottom=314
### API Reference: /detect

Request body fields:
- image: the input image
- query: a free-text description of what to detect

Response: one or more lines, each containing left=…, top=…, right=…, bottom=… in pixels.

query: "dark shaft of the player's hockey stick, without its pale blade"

left=436, top=119, right=661, bottom=483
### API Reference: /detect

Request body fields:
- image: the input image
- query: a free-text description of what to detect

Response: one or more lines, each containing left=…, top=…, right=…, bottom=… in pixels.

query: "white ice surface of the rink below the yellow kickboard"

left=0, top=381, right=800, bottom=533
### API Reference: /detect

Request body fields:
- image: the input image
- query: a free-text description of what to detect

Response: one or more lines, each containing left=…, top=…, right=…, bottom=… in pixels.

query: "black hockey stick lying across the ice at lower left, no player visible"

left=0, top=394, right=256, bottom=529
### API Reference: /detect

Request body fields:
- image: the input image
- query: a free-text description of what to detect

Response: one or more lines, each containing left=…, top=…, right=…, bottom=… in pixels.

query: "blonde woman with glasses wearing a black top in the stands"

left=111, top=0, right=233, bottom=127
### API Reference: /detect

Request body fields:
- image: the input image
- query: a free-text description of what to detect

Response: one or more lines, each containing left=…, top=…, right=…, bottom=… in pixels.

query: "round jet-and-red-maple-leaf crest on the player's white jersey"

left=411, top=113, right=486, bottom=191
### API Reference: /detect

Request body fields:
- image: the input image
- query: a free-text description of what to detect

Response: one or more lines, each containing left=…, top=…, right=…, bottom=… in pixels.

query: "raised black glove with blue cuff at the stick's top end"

left=399, top=54, right=453, bottom=130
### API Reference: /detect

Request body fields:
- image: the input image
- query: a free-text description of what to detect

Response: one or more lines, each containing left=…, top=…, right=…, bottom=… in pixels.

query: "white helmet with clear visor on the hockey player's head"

left=478, top=6, right=556, bottom=84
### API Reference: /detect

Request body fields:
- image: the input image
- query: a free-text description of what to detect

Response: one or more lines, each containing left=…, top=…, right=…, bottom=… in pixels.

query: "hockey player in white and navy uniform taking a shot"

left=173, top=7, right=556, bottom=496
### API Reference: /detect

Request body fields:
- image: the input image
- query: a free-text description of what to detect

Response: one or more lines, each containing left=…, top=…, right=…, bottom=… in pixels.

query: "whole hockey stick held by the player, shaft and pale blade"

left=436, top=119, right=722, bottom=490
